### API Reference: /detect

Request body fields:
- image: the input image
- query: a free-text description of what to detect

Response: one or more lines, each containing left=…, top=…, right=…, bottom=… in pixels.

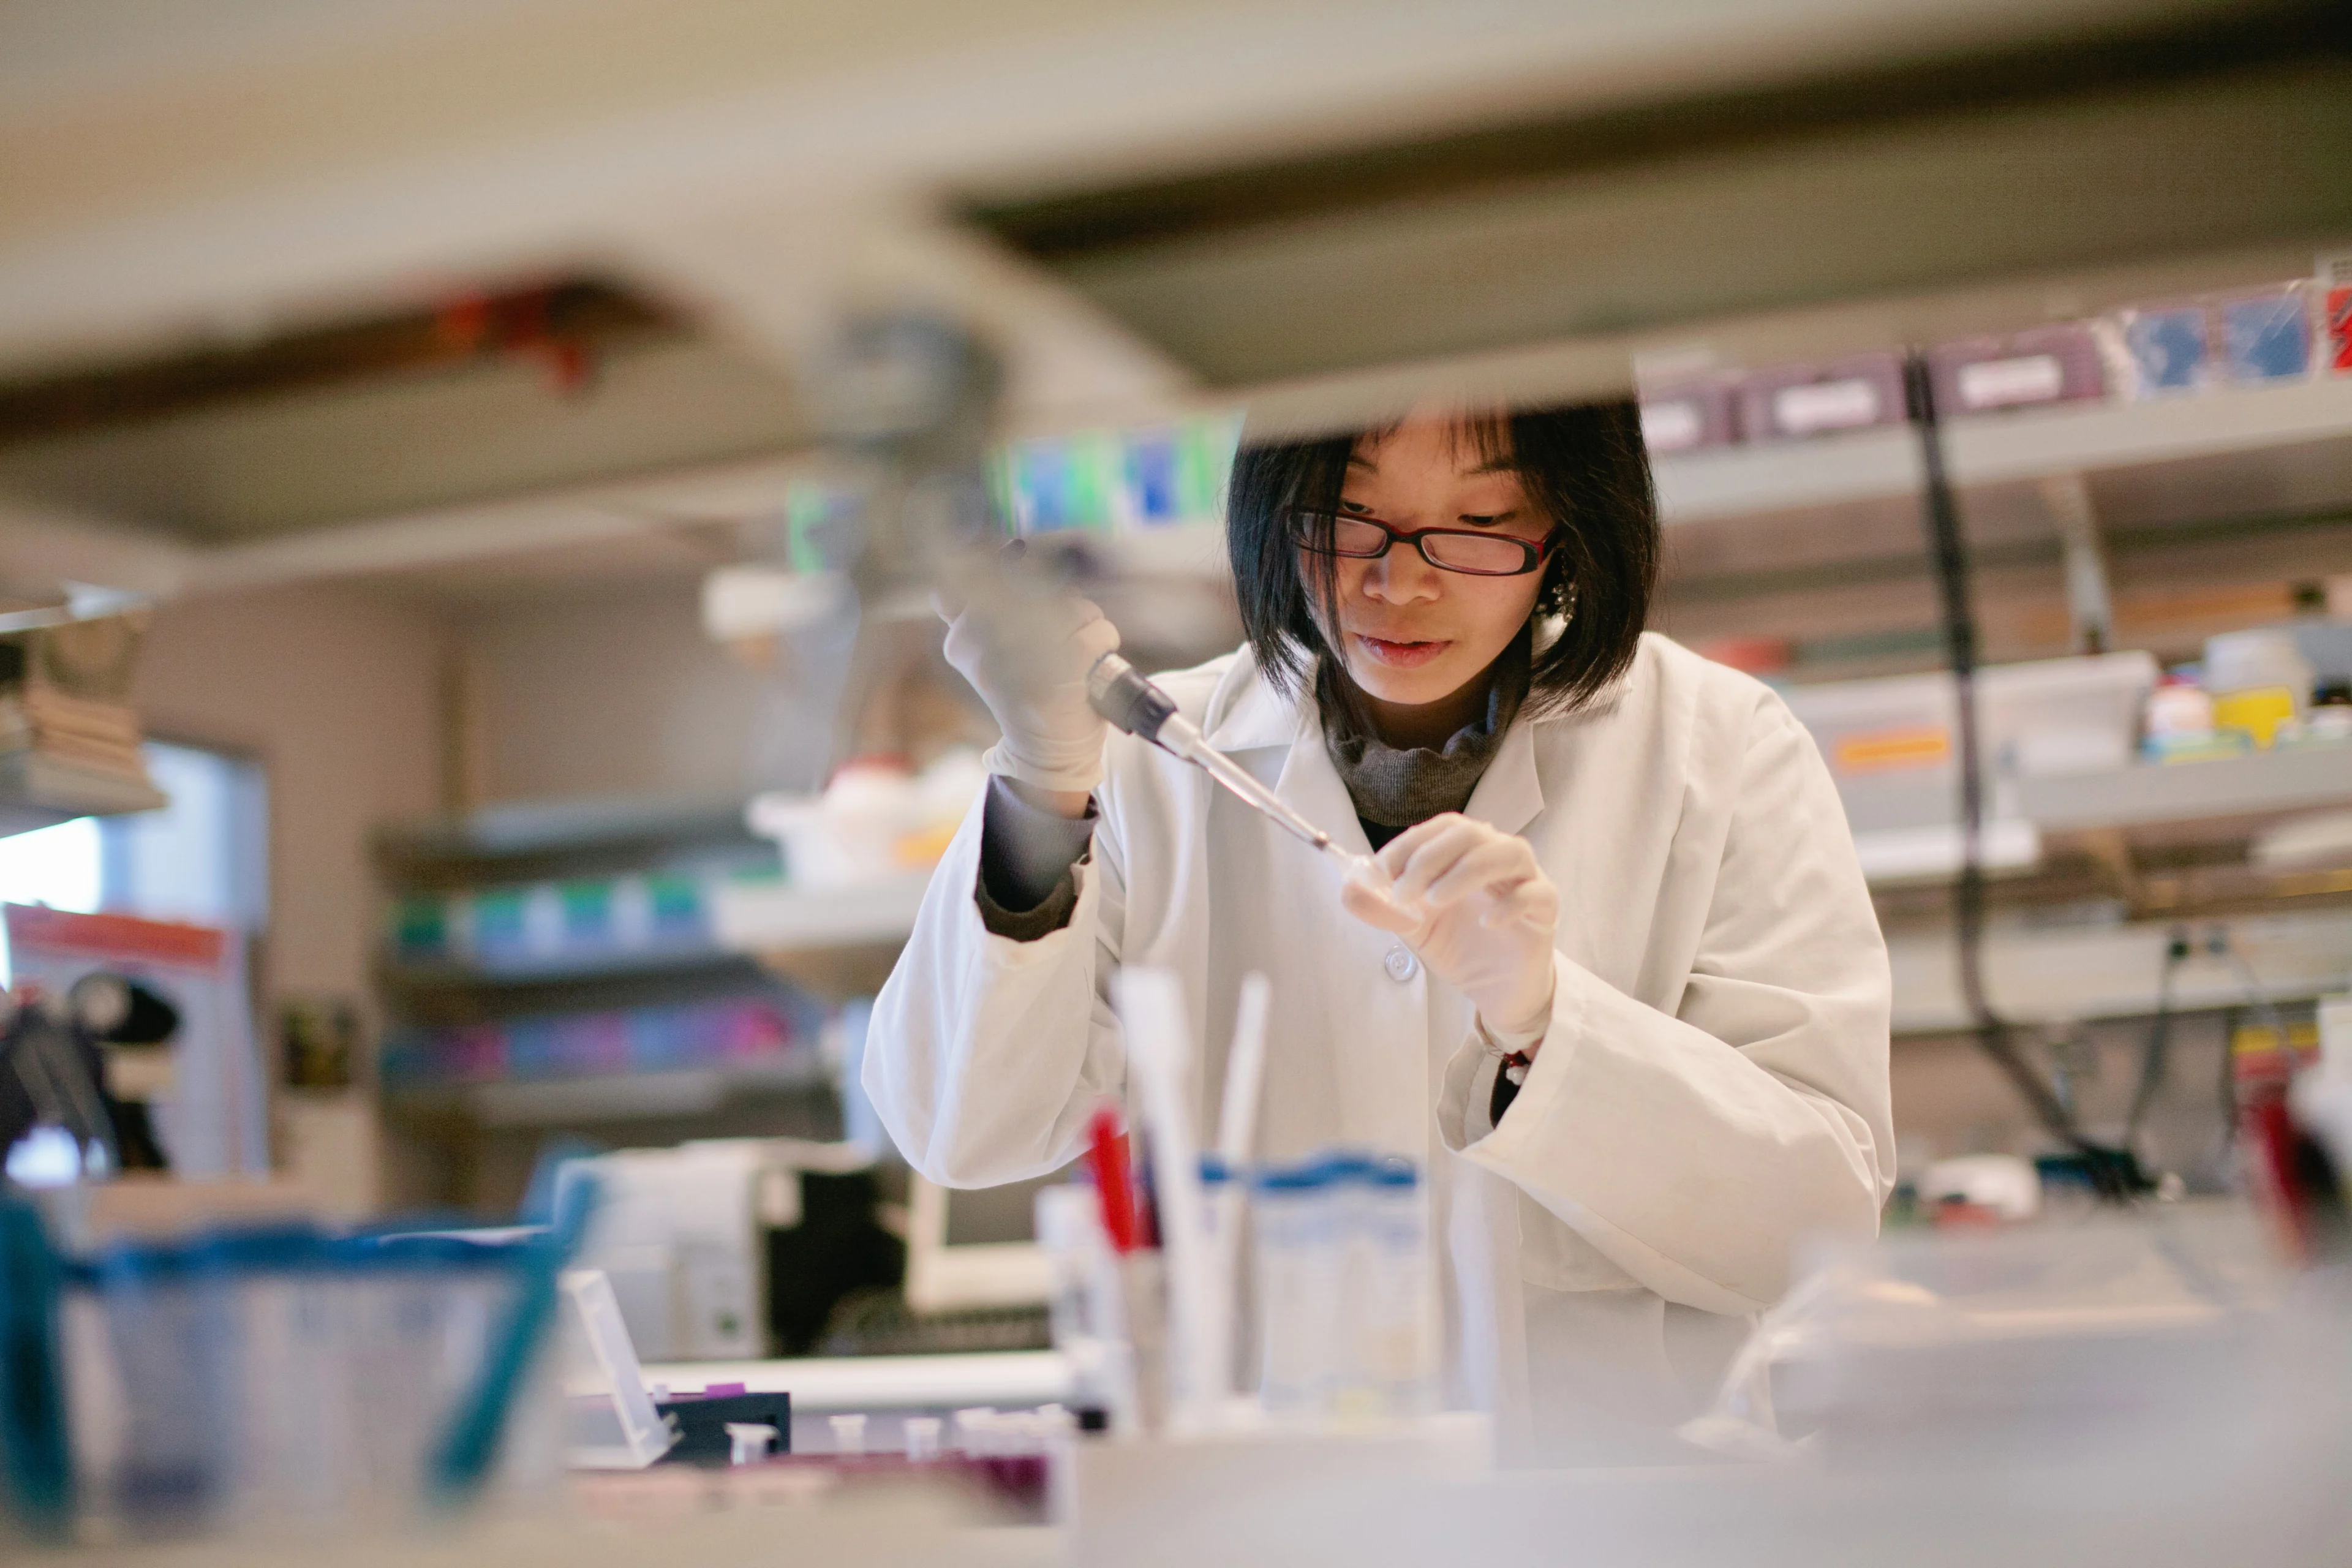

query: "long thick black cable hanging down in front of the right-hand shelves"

left=1903, top=353, right=2147, bottom=1199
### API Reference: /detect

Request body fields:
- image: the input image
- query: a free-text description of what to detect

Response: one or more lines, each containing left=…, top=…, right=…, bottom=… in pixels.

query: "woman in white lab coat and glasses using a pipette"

left=863, top=407, right=1893, bottom=1462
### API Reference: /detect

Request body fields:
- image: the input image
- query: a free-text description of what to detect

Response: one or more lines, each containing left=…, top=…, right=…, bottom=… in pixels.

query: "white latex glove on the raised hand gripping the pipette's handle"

left=932, top=595, right=1120, bottom=794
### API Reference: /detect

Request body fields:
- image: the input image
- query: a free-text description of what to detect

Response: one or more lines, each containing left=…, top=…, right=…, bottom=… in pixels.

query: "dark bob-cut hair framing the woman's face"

left=1226, top=402, right=1658, bottom=712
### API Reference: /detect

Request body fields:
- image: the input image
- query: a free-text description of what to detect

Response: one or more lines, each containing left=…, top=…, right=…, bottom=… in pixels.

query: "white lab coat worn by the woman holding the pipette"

left=863, top=635, right=1893, bottom=1462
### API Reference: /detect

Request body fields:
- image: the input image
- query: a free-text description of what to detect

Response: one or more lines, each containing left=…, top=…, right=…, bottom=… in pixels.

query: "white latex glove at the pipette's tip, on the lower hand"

left=1341, top=811, right=1559, bottom=1037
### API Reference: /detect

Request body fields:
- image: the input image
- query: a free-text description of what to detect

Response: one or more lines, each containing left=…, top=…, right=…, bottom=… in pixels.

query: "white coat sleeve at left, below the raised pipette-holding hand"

left=861, top=785, right=1126, bottom=1187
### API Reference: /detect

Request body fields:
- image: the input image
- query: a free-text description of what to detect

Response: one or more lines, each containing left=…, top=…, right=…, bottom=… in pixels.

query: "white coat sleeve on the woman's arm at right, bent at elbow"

left=1439, top=698, right=1893, bottom=1312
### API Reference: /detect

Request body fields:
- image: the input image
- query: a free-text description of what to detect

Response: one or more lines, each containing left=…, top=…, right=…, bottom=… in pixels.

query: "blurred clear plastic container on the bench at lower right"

left=1684, top=1208, right=2295, bottom=1474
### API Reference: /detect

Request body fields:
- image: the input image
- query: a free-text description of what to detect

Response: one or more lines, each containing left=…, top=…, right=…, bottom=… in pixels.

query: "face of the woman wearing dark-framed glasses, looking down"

left=1301, top=418, right=1552, bottom=707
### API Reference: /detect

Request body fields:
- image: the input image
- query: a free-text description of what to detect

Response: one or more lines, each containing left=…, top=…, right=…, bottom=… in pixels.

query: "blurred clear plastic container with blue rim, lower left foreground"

left=64, top=1227, right=562, bottom=1537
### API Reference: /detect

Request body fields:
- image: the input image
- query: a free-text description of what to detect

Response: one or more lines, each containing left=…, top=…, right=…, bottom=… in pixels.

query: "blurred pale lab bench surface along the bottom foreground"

left=31, top=1434, right=2343, bottom=1568
